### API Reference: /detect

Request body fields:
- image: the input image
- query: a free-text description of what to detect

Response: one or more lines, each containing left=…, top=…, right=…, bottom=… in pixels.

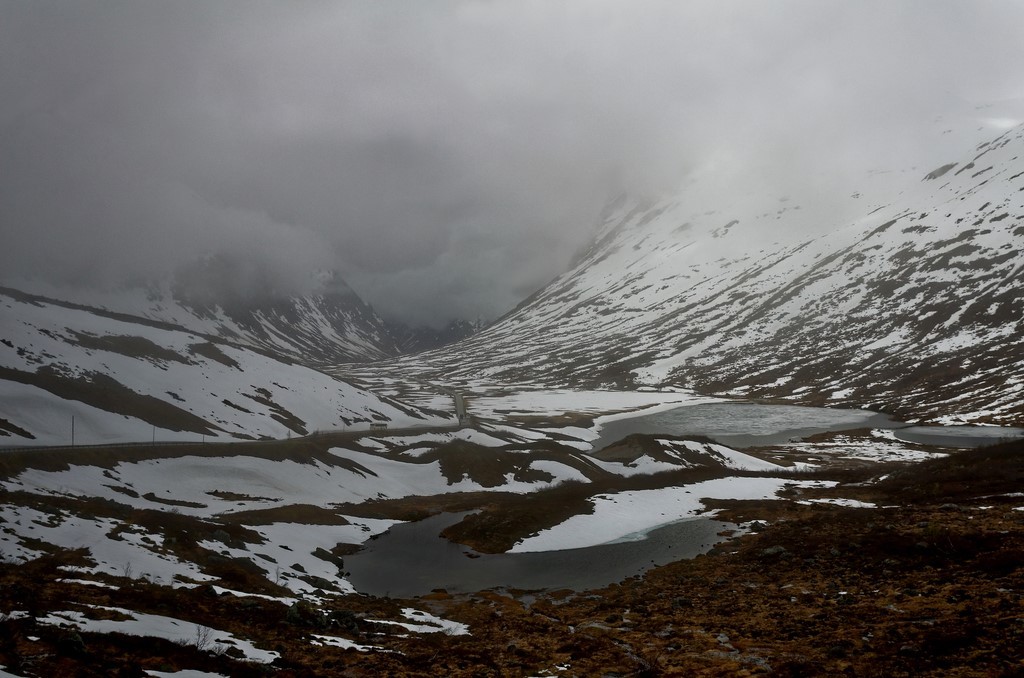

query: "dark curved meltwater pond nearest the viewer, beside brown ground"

left=345, top=513, right=735, bottom=597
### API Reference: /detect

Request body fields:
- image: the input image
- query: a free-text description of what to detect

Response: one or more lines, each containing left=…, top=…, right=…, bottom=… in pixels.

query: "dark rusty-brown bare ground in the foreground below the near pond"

left=0, top=443, right=1024, bottom=676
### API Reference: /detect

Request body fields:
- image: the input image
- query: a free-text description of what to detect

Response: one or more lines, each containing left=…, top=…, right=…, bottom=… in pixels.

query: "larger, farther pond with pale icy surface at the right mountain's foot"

left=594, top=402, right=902, bottom=450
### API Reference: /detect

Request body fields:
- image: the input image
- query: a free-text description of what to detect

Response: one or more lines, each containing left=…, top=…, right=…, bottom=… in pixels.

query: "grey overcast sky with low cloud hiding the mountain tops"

left=0, top=0, right=1024, bottom=324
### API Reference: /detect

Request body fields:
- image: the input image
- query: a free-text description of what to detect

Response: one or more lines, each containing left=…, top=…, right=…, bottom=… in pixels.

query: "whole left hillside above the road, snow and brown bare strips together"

left=0, top=290, right=450, bottom=446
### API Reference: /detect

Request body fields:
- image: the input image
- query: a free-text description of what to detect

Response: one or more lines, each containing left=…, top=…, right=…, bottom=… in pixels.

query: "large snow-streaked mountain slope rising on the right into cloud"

left=372, top=126, right=1024, bottom=423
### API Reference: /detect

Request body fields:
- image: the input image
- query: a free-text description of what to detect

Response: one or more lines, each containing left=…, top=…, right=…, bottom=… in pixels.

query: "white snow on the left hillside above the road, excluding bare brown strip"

left=0, top=297, right=442, bottom=444
